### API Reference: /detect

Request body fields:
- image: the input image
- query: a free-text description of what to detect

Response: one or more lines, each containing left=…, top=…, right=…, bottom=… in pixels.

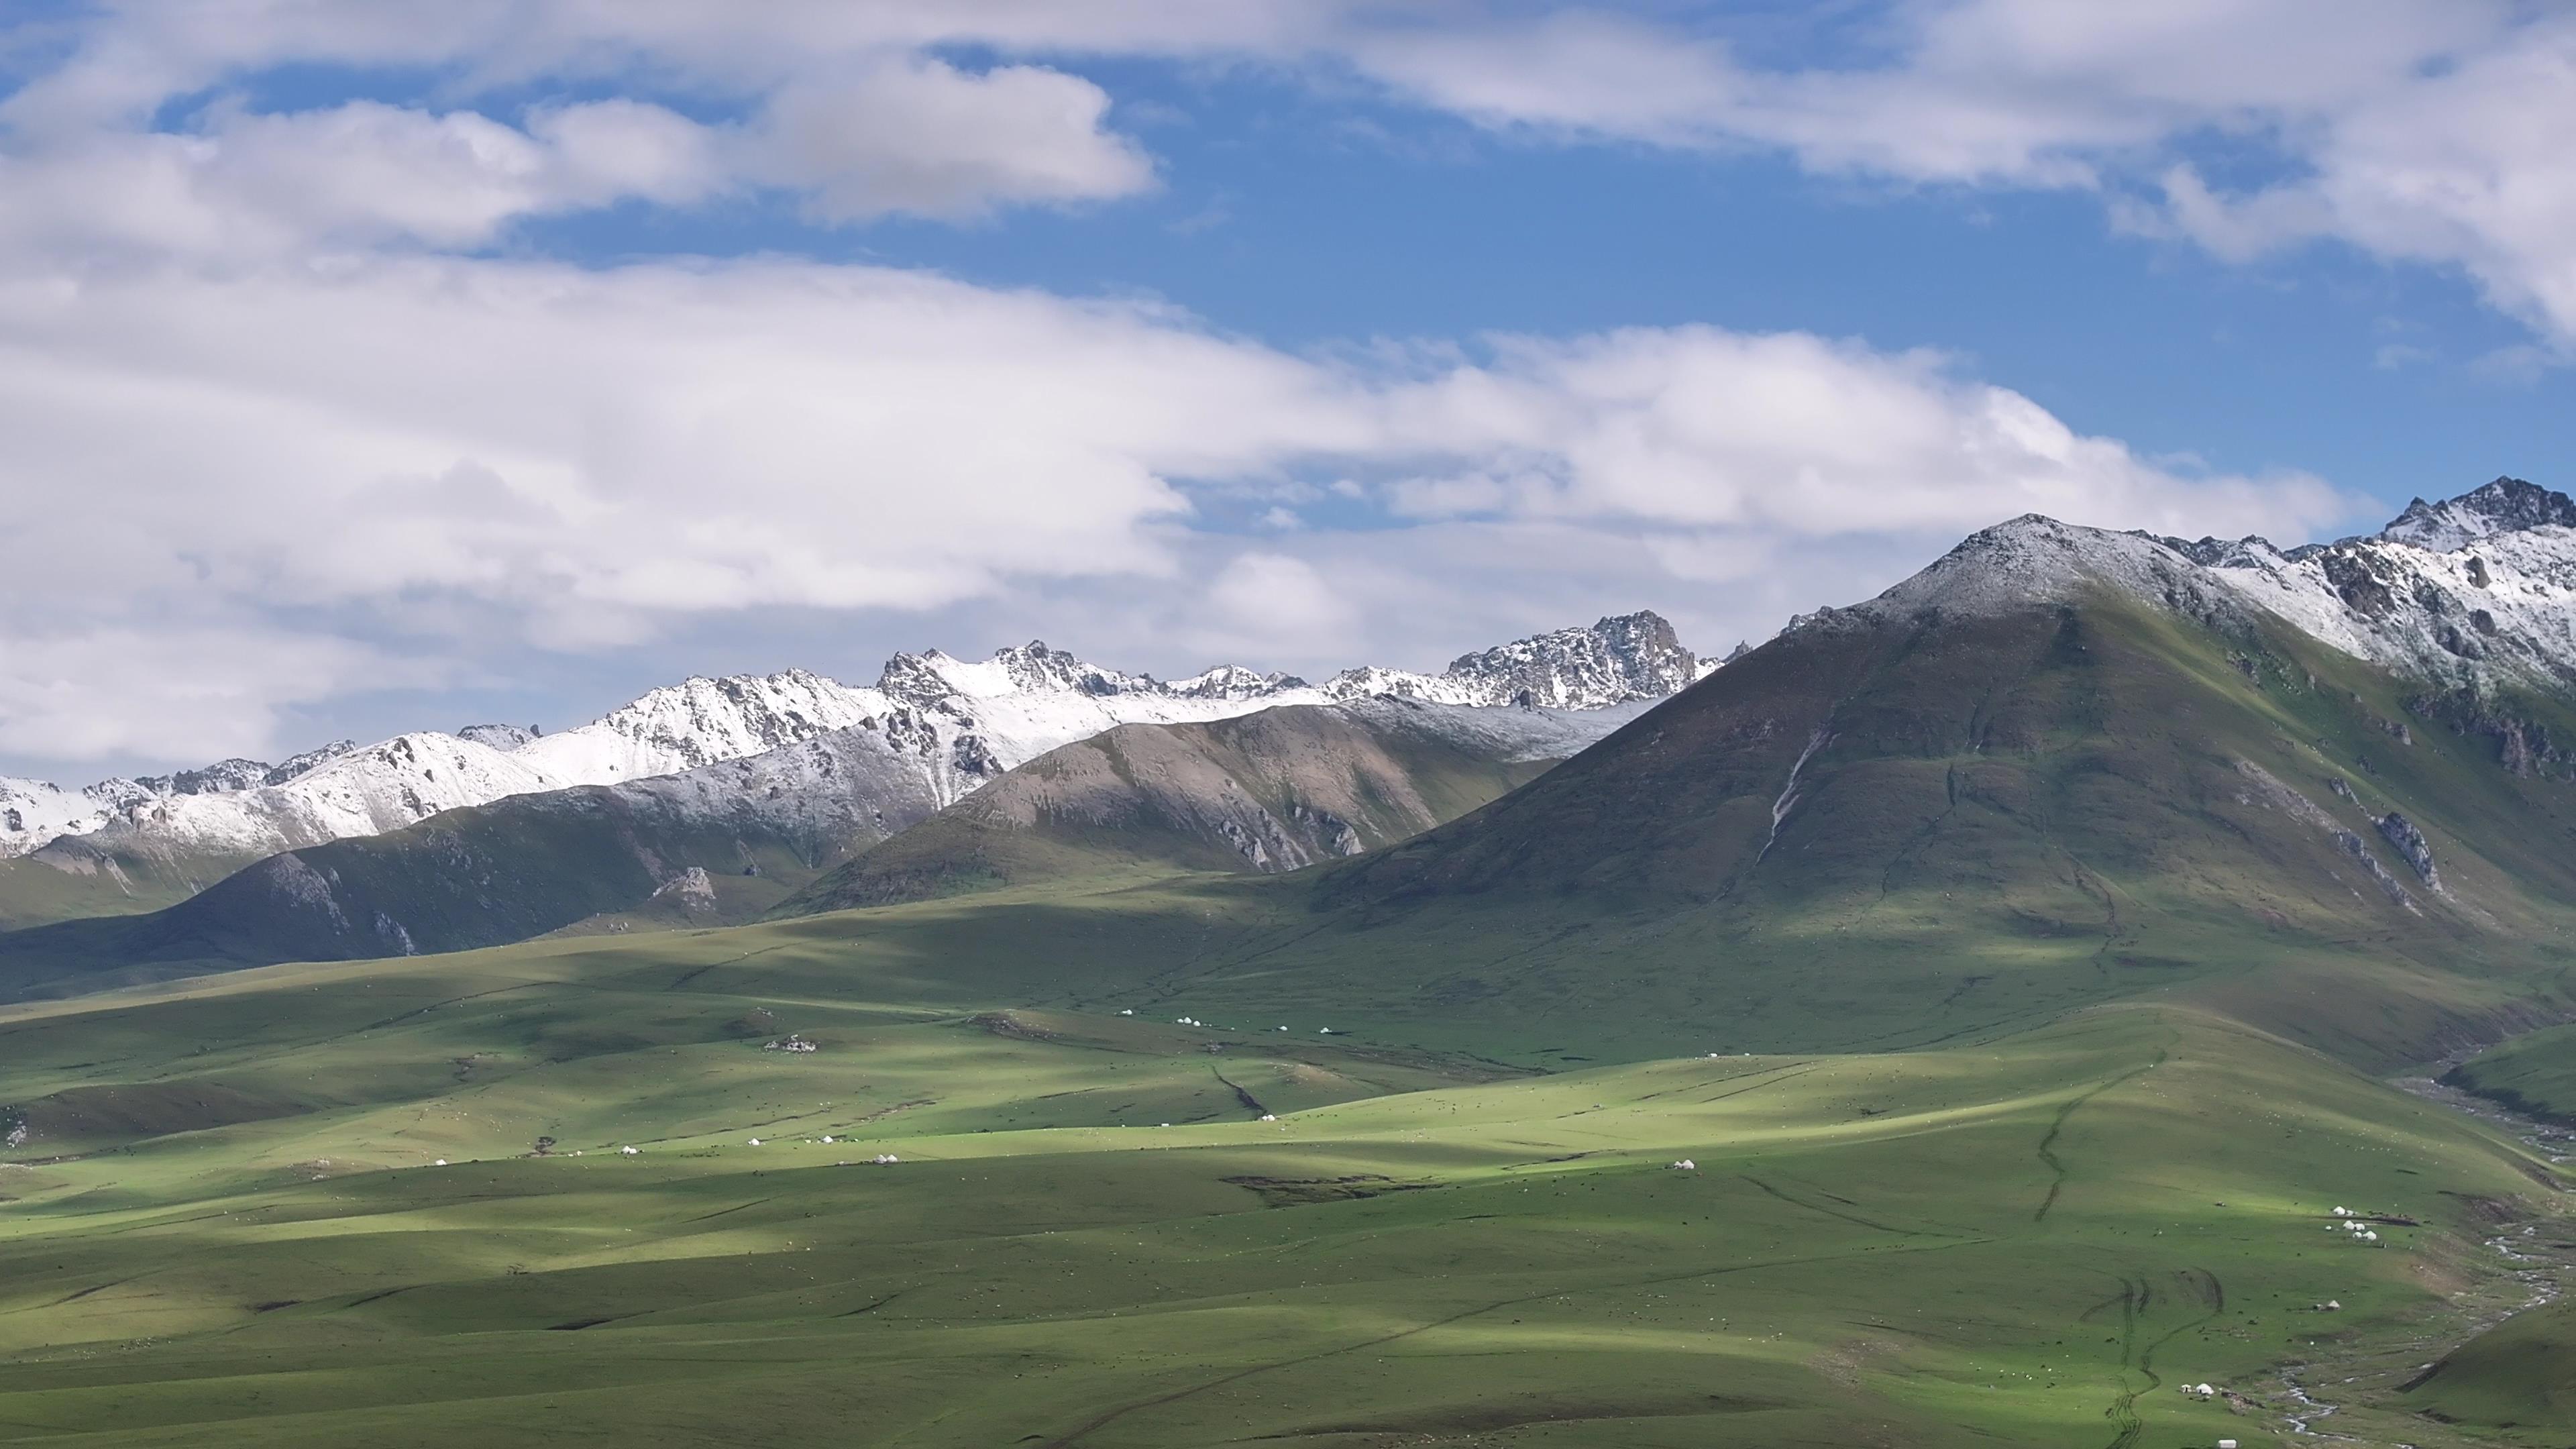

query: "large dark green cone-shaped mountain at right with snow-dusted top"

left=1138, top=521, right=2576, bottom=1060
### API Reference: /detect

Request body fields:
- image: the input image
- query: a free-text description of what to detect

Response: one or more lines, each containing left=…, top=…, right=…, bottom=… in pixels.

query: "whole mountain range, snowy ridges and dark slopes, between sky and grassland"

left=0, top=480, right=2576, bottom=1042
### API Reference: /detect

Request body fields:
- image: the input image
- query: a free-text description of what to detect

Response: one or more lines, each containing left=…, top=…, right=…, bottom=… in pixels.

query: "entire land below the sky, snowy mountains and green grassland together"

left=15, top=480, right=2576, bottom=1449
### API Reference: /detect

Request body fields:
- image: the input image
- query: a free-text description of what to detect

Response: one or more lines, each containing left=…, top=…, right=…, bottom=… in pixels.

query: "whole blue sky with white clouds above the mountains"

left=0, top=0, right=2576, bottom=779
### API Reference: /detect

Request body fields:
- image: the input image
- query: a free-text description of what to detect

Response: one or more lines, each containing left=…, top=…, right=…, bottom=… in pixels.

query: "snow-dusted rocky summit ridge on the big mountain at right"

left=1793, top=477, right=2576, bottom=688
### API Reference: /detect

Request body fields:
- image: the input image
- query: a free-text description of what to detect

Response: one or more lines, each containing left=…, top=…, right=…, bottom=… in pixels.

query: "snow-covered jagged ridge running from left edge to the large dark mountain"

left=0, top=603, right=1695, bottom=869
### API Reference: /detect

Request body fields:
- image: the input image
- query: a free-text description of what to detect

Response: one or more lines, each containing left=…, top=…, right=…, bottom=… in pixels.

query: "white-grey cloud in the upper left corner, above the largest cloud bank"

left=0, top=0, right=1179, bottom=255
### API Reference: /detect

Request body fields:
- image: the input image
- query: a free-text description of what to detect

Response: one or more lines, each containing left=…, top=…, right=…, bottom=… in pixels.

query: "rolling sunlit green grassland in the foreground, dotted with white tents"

left=0, top=908, right=2555, bottom=1449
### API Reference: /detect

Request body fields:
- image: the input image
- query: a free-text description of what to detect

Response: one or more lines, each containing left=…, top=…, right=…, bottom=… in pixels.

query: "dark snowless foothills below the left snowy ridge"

left=0, top=701, right=1592, bottom=998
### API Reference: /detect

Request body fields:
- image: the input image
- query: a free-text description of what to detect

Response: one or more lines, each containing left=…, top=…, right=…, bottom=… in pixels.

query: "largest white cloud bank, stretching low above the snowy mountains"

left=0, top=245, right=2352, bottom=768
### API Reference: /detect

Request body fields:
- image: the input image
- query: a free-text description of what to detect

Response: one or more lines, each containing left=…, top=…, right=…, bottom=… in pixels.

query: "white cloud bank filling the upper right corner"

left=1347, top=0, right=2576, bottom=348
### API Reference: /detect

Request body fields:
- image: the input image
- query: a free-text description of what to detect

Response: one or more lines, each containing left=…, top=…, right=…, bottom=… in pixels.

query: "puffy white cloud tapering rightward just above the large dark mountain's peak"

left=1391, top=327, right=2352, bottom=536
